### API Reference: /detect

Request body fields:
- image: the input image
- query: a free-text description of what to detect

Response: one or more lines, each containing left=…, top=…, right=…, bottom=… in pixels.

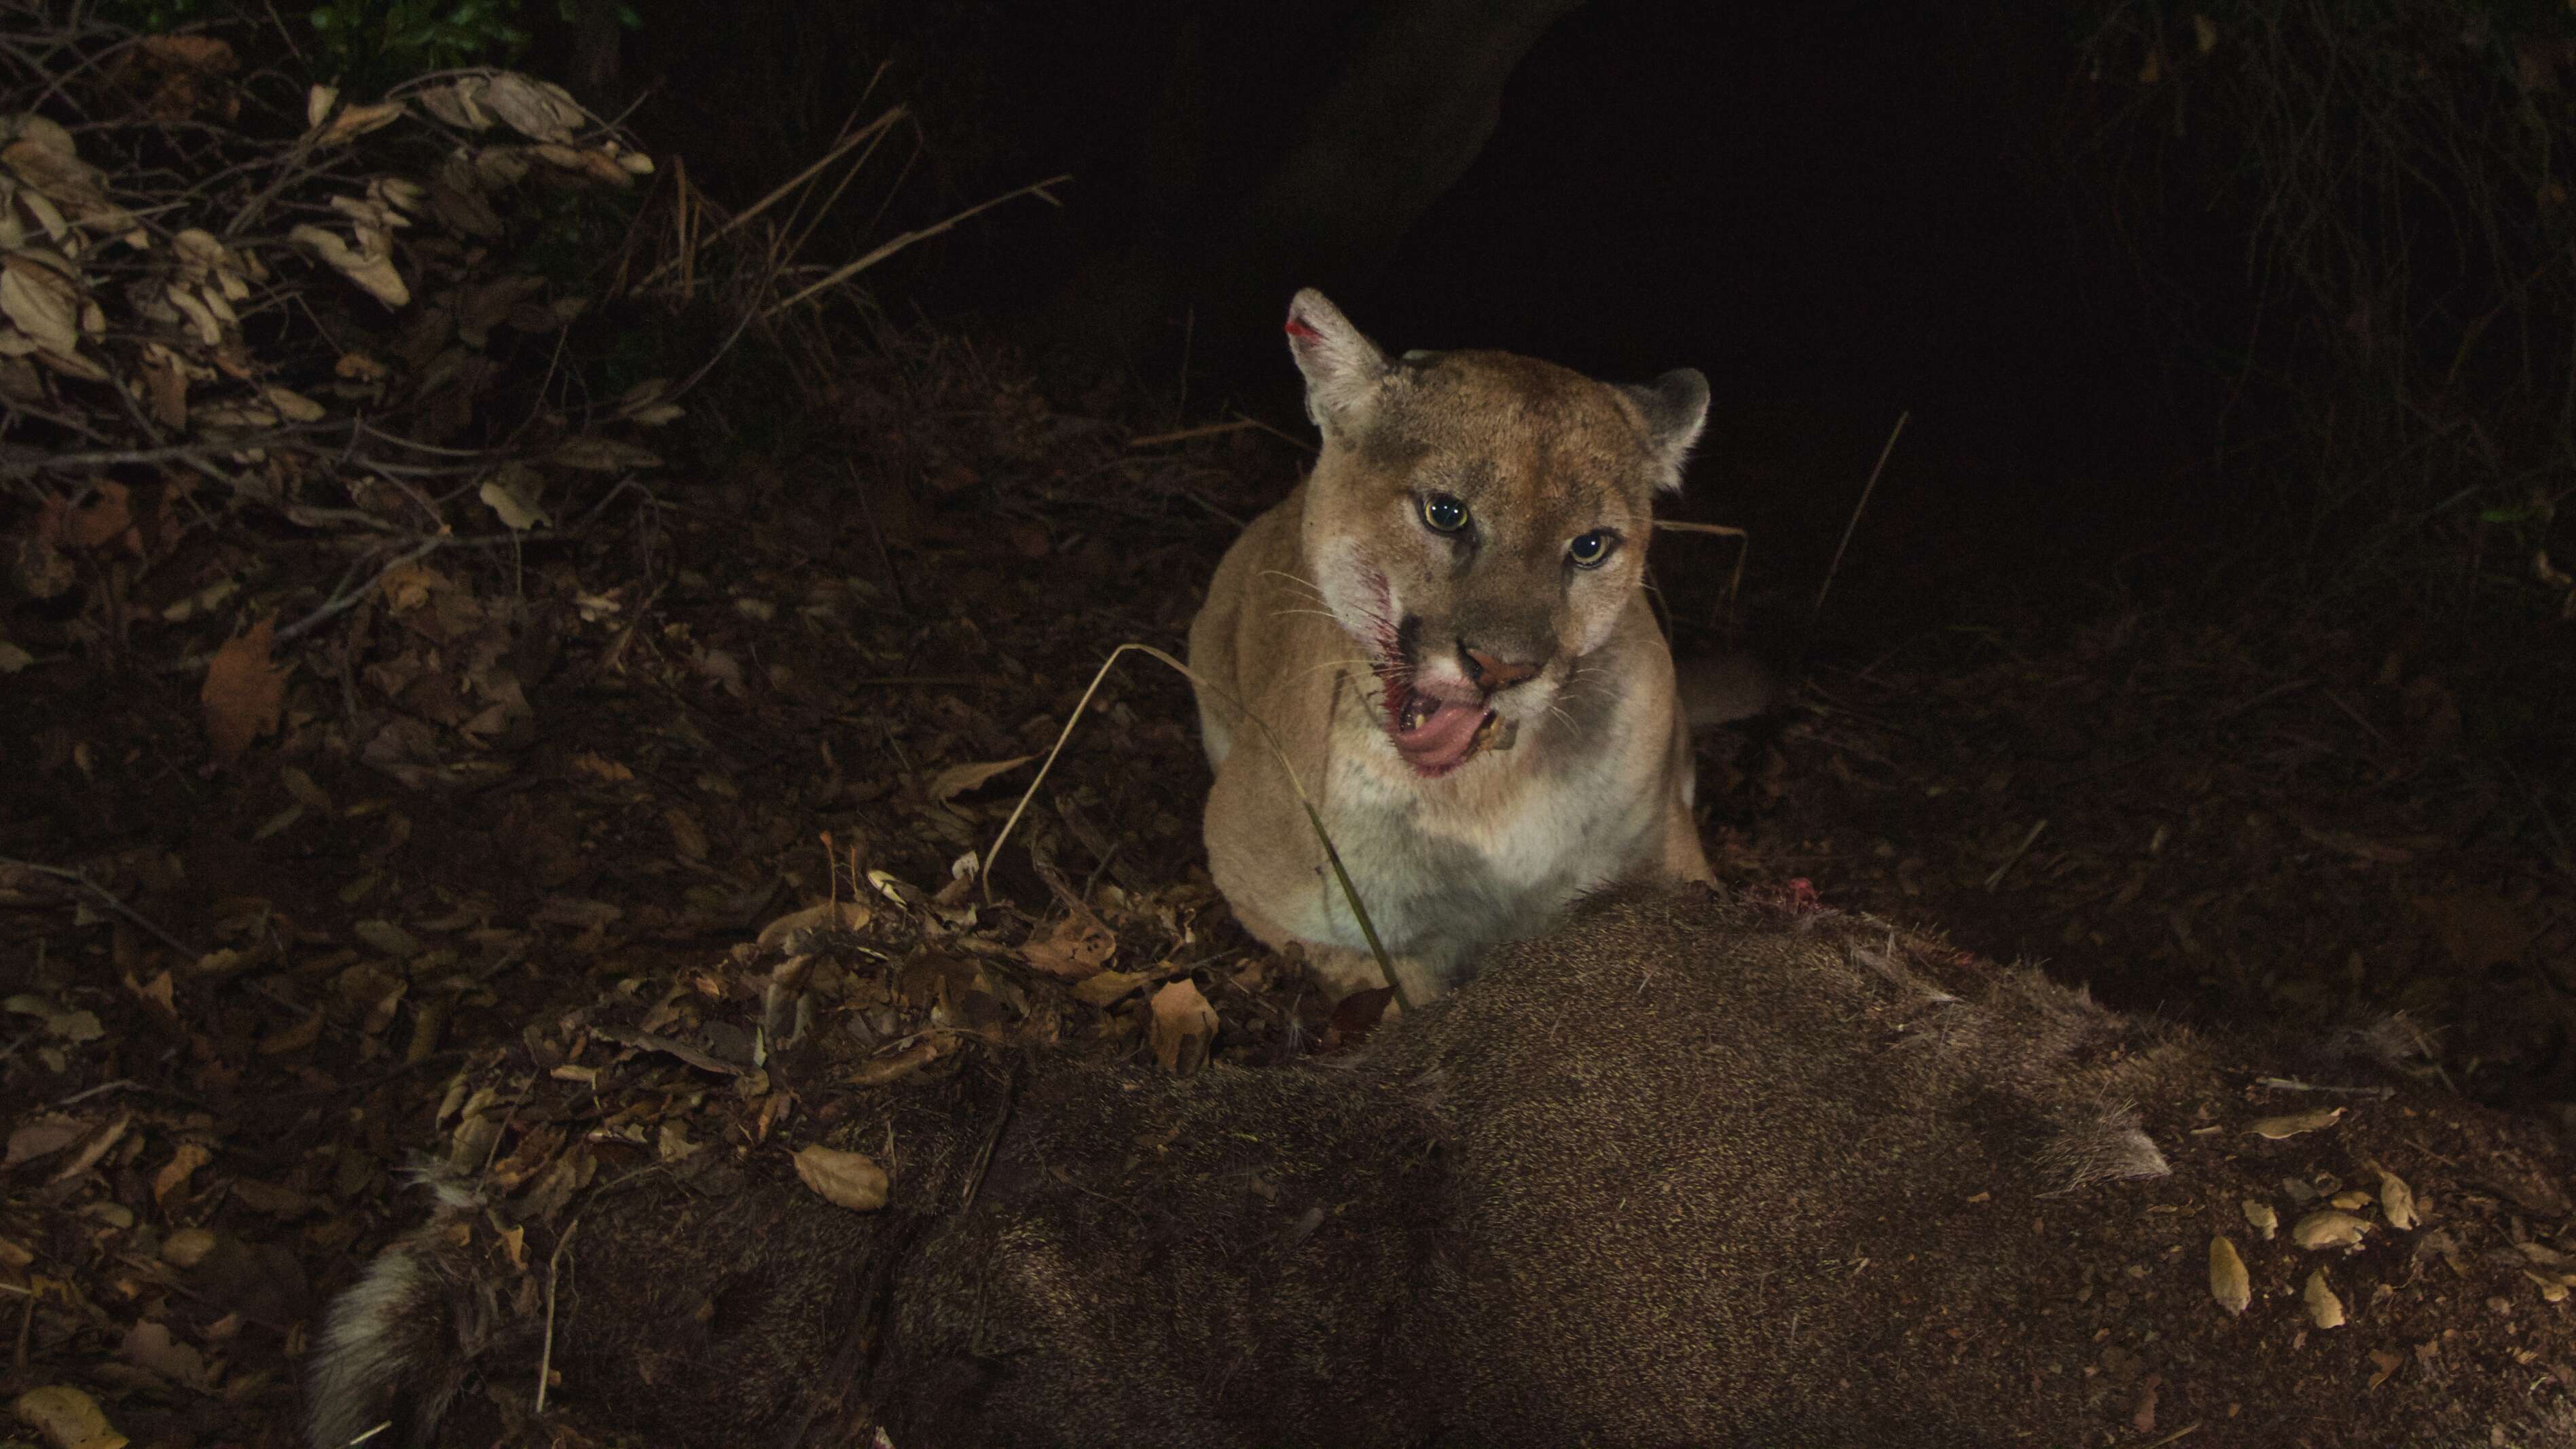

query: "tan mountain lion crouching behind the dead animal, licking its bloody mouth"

left=1190, top=291, right=1767, bottom=1001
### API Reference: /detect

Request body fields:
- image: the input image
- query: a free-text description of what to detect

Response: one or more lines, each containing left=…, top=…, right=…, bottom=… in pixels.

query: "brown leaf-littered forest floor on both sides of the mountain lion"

left=0, top=323, right=2576, bottom=1446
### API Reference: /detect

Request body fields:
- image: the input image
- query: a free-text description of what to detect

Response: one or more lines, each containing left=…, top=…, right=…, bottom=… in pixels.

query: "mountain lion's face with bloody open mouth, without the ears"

left=1306, top=352, right=1674, bottom=775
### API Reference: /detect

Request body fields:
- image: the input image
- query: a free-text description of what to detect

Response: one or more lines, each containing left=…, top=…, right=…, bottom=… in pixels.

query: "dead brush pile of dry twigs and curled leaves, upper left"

left=0, top=3, right=1061, bottom=788
